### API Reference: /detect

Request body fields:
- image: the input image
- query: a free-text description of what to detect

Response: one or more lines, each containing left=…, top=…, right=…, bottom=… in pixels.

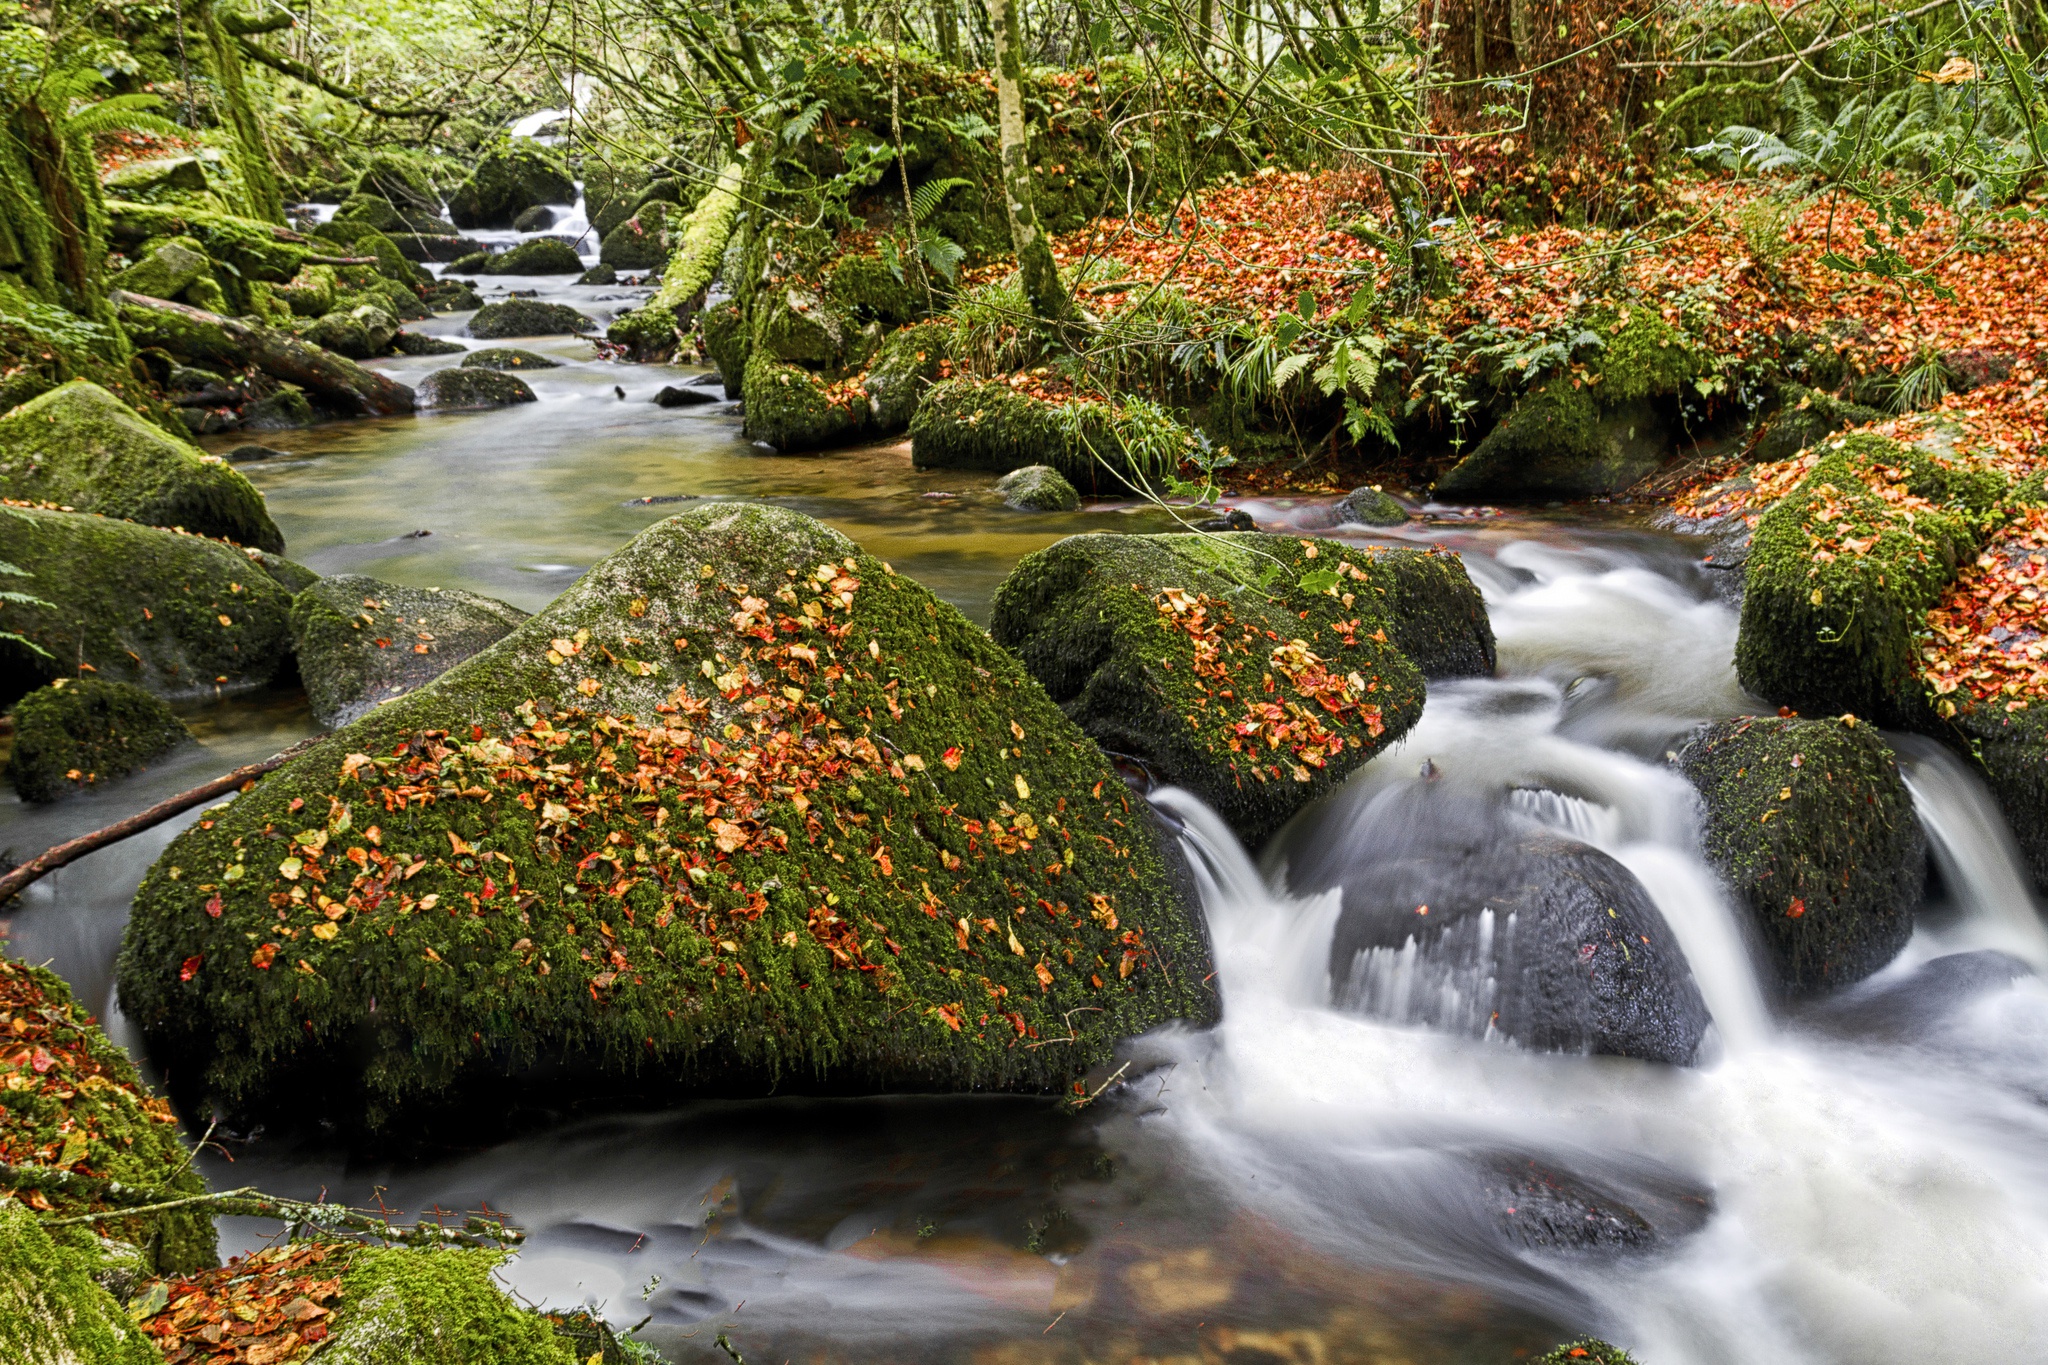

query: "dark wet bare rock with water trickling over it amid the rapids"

left=1288, top=784, right=1708, bottom=1066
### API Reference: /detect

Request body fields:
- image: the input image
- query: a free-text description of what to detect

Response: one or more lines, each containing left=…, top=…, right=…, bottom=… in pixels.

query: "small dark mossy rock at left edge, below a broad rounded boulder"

left=6, top=677, right=190, bottom=802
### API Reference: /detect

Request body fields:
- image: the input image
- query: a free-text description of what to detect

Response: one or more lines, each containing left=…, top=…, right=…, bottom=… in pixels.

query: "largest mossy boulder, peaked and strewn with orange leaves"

left=121, top=503, right=1214, bottom=1138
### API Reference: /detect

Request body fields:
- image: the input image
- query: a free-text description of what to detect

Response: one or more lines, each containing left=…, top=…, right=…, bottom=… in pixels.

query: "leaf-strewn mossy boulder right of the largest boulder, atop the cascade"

left=989, top=532, right=1491, bottom=847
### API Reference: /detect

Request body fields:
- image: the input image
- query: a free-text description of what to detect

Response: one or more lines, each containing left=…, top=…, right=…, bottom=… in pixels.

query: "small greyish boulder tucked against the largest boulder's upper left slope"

left=291, top=573, right=526, bottom=731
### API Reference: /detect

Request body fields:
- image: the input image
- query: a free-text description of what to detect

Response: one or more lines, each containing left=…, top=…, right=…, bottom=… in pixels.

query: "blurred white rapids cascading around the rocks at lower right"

left=1137, top=542, right=2048, bottom=1365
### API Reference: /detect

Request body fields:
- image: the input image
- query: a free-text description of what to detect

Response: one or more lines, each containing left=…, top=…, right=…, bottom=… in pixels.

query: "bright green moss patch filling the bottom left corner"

left=0, top=1199, right=162, bottom=1365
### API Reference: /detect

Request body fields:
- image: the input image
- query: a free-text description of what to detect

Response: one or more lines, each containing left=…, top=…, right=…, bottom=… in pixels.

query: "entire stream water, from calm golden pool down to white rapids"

left=0, top=278, right=2048, bottom=1365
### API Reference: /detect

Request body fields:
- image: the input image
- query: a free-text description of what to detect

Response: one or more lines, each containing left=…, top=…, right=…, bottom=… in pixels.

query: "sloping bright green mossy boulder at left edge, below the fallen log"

left=0, top=379, right=285, bottom=551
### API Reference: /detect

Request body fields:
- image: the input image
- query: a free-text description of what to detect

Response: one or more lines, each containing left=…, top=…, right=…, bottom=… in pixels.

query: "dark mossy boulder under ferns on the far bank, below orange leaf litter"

left=1436, top=375, right=1671, bottom=501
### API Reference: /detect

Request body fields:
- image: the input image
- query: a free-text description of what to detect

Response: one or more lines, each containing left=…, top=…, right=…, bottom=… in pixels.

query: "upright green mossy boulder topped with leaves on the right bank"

left=1735, top=432, right=2007, bottom=729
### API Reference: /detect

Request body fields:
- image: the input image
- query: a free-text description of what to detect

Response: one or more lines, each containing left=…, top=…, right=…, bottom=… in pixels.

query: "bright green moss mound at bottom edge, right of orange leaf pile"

left=319, top=1246, right=580, bottom=1365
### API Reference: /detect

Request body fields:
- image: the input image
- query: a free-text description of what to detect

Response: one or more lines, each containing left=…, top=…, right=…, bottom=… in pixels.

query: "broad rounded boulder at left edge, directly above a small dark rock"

left=0, top=508, right=291, bottom=704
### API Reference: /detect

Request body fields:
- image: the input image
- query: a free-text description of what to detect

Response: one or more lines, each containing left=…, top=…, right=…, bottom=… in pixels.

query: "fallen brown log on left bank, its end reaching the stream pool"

left=113, top=291, right=414, bottom=417
